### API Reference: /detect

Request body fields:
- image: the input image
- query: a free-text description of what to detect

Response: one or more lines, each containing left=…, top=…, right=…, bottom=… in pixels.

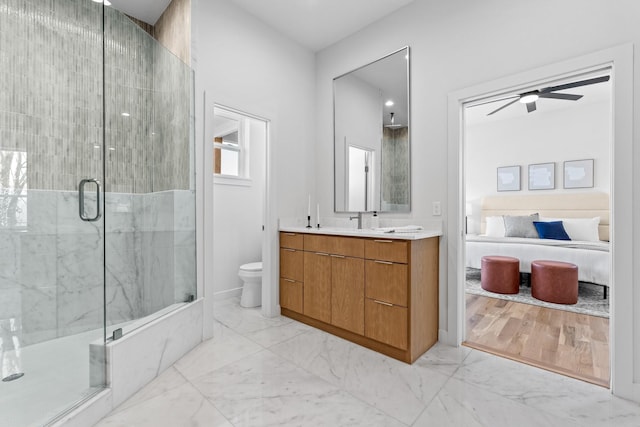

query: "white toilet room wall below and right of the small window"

left=212, top=119, right=267, bottom=298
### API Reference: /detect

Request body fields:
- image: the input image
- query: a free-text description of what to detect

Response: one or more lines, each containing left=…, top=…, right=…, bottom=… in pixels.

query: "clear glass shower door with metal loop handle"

left=0, top=0, right=105, bottom=426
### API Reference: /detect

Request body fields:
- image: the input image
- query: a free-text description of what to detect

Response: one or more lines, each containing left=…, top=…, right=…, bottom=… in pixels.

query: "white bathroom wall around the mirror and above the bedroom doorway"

left=315, top=0, right=640, bottom=346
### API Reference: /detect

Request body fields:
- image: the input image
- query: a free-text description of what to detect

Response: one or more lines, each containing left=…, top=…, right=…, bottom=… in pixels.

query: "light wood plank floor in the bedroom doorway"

left=463, top=294, right=610, bottom=387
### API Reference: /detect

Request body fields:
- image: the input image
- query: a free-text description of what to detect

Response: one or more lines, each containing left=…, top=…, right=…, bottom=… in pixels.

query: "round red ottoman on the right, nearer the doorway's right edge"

left=531, top=261, right=578, bottom=304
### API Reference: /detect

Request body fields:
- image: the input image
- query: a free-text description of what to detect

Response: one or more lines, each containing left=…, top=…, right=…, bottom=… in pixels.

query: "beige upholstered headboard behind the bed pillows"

left=480, top=193, right=609, bottom=241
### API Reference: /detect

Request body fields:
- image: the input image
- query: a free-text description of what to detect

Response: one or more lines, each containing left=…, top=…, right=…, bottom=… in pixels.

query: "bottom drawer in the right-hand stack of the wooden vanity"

left=364, top=298, right=408, bottom=350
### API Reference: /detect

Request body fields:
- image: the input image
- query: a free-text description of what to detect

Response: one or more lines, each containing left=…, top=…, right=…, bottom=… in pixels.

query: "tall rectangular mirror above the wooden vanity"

left=333, top=47, right=411, bottom=212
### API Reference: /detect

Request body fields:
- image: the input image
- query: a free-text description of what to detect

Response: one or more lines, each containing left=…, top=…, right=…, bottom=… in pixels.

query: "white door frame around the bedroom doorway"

left=441, top=44, right=640, bottom=401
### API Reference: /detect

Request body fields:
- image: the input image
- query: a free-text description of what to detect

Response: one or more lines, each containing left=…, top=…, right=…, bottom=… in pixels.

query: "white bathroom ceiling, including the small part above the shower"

left=110, top=0, right=414, bottom=52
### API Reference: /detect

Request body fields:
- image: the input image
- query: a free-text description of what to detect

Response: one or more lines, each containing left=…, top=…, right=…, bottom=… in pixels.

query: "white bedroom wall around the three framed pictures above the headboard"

left=465, top=101, right=611, bottom=233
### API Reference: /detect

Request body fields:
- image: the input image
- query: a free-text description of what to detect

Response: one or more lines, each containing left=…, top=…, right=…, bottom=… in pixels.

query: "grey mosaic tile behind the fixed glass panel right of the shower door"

left=104, top=8, right=192, bottom=193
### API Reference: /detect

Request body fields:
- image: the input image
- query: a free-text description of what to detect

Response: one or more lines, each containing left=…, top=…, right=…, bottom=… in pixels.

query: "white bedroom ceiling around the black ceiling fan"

left=465, top=72, right=611, bottom=125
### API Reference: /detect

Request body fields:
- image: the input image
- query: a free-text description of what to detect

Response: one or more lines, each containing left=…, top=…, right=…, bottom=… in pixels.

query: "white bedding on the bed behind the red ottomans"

left=466, top=235, right=610, bottom=286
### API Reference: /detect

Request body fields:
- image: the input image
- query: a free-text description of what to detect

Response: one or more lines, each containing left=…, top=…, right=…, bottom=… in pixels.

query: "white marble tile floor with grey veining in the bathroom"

left=97, top=299, right=640, bottom=427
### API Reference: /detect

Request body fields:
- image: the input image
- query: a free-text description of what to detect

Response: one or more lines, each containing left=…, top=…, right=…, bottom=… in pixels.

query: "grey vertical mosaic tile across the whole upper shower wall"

left=0, top=0, right=191, bottom=193
